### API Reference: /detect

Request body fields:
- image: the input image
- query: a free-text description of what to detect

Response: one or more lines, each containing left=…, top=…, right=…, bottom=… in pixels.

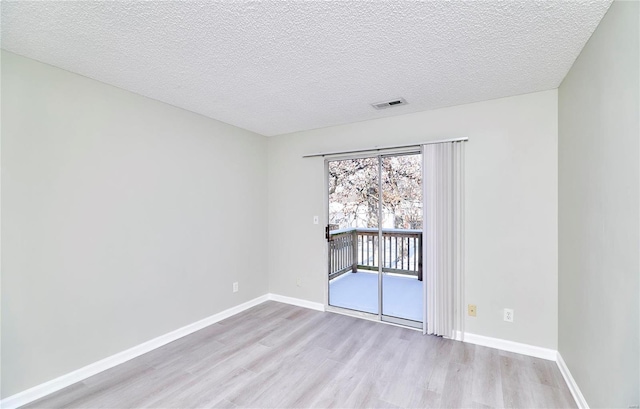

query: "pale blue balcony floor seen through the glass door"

left=329, top=271, right=423, bottom=322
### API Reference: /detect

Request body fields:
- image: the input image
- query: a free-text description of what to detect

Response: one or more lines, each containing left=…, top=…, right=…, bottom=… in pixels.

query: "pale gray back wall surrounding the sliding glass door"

left=268, top=90, right=558, bottom=349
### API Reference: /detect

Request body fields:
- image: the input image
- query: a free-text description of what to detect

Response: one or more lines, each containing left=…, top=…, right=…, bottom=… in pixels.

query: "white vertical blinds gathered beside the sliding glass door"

left=422, top=142, right=465, bottom=339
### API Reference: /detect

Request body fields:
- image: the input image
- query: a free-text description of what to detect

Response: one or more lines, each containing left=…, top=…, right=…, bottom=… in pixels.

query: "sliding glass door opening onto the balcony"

left=327, top=153, right=423, bottom=327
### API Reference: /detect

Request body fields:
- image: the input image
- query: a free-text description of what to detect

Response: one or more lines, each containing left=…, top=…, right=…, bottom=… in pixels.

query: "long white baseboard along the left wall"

left=0, top=294, right=268, bottom=409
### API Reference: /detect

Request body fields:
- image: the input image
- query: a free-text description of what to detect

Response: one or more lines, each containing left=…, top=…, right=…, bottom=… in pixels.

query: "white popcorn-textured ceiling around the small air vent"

left=1, top=0, right=611, bottom=135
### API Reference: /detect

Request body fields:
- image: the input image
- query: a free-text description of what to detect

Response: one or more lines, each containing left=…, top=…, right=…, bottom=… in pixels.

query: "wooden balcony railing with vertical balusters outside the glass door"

left=329, top=228, right=422, bottom=280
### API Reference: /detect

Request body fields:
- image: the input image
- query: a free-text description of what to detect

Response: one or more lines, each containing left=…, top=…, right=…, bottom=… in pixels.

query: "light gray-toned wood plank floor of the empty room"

left=23, top=301, right=575, bottom=408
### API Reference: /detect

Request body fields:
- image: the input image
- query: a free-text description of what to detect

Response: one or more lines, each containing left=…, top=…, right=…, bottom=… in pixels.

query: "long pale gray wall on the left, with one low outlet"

left=1, top=52, right=268, bottom=397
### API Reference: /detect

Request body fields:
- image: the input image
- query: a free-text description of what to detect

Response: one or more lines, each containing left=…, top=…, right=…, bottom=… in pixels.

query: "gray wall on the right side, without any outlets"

left=559, top=1, right=640, bottom=408
